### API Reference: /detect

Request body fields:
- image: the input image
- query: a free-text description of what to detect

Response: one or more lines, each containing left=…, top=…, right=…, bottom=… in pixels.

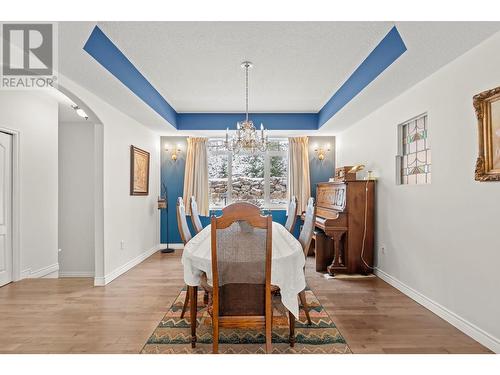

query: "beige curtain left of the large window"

left=183, top=137, right=208, bottom=216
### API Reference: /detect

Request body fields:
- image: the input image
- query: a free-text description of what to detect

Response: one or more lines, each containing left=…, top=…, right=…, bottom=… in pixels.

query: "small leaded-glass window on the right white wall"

left=397, top=114, right=431, bottom=185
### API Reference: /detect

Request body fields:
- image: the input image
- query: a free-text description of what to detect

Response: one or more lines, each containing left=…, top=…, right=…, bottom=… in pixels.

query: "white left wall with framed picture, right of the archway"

left=59, top=76, right=160, bottom=285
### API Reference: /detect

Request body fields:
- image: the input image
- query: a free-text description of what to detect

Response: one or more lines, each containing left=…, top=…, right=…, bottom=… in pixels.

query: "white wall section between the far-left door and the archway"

left=0, top=91, right=58, bottom=277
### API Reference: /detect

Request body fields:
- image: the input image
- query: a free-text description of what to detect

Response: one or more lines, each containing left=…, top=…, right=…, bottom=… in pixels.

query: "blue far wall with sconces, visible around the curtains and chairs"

left=160, top=136, right=335, bottom=243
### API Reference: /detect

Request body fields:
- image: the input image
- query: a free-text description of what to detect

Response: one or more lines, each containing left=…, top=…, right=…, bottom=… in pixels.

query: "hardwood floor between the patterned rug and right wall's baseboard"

left=306, top=266, right=491, bottom=354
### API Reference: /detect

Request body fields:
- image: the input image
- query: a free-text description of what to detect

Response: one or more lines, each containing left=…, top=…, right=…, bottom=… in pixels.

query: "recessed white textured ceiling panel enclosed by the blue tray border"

left=94, top=22, right=392, bottom=112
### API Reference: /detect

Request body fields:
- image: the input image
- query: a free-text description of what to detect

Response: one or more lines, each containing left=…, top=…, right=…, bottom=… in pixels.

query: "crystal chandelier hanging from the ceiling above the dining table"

left=224, top=61, right=268, bottom=153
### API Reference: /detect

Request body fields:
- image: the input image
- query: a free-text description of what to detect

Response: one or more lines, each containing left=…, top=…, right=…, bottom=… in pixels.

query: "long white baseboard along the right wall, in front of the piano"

left=375, top=268, right=500, bottom=353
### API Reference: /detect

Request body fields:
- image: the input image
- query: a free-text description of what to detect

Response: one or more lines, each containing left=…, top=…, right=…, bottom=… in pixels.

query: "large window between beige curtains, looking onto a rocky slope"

left=208, top=139, right=288, bottom=209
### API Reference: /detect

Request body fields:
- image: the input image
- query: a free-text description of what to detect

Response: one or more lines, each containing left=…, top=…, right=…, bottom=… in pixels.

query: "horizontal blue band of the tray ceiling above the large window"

left=177, top=113, right=318, bottom=130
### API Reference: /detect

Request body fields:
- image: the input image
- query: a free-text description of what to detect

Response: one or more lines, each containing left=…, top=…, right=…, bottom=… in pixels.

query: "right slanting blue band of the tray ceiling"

left=318, top=26, right=406, bottom=128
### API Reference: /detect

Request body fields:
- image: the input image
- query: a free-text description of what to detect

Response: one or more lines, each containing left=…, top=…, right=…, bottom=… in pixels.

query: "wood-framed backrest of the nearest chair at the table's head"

left=211, top=202, right=272, bottom=317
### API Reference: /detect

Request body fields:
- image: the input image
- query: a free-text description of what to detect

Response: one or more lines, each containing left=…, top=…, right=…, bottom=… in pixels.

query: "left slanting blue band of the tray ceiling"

left=83, top=26, right=177, bottom=127
